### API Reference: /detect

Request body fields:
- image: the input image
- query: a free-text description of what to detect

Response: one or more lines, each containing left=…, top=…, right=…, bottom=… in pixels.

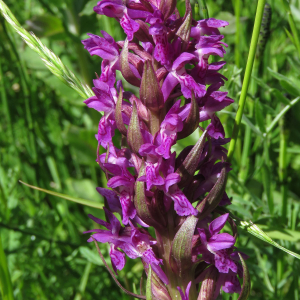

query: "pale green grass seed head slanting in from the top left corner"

left=0, top=0, right=93, bottom=98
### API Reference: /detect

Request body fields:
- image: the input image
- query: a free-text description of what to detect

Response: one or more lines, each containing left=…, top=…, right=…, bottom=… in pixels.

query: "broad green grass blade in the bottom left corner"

left=0, top=234, right=14, bottom=300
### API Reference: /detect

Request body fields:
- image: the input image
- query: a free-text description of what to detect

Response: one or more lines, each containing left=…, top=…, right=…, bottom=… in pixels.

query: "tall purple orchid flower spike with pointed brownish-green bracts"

left=83, top=0, right=247, bottom=300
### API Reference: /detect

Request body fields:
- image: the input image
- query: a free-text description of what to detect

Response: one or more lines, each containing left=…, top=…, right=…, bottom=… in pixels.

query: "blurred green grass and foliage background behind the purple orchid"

left=0, top=0, right=300, bottom=300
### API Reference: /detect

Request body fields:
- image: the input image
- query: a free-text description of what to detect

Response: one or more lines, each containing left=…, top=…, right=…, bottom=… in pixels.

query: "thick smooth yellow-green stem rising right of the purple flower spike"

left=227, top=0, right=266, bottom=161
